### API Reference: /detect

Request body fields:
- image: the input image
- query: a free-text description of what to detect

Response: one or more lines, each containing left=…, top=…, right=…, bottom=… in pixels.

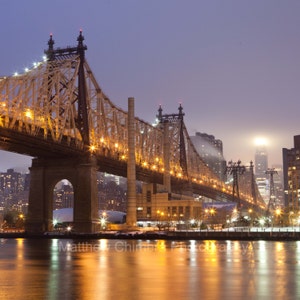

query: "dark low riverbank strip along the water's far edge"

left=0, top=230, right=300, bottom=241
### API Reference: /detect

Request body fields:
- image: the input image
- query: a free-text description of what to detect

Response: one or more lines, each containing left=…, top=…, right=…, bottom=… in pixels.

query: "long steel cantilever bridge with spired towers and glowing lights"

left=0, top=32, right=265, bottom=232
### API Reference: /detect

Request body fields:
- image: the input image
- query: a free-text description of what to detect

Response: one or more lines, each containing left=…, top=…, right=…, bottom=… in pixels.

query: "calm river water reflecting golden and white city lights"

left=0, top=238, right=300, bottom=300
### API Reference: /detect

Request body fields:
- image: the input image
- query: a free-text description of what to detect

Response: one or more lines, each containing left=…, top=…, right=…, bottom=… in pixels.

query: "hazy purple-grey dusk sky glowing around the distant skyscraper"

left=0, top=0, right=300, bottom=171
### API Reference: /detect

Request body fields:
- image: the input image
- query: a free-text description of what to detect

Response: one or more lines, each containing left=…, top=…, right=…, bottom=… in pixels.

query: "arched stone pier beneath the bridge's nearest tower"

left=26, top=157, right=99, bottom=233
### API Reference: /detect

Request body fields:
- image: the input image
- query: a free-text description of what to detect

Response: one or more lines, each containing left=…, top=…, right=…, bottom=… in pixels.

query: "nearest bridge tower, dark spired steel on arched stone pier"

left=26, top=31, right=99, bottom=233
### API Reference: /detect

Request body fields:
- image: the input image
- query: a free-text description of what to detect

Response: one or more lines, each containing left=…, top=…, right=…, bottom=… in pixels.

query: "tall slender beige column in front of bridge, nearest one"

left=126, top=98, right=137, bottom=227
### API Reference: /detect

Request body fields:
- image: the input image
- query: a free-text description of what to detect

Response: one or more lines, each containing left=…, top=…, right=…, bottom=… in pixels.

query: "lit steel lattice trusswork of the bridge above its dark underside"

left=0, top=32, right=263, bottom=211
